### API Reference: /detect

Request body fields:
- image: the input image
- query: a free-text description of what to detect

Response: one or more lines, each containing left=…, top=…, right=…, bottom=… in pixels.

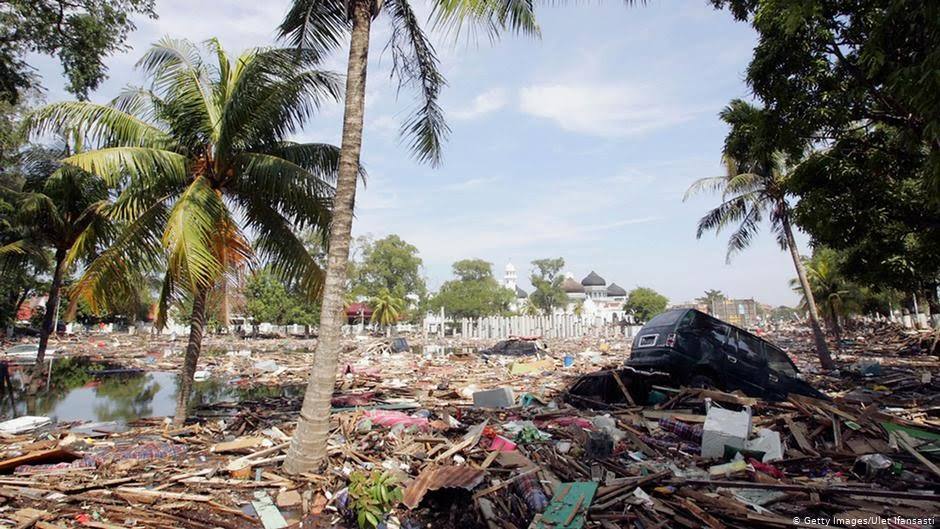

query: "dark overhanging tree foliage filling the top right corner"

left=712, top=0, right=940, bottom=196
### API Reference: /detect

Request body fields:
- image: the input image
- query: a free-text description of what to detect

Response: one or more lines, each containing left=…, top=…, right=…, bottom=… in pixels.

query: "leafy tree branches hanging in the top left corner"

left=0, top=0, right=156, bottom=102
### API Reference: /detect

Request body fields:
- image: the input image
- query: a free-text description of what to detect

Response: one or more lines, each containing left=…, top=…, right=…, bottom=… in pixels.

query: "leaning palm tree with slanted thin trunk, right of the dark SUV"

left=685, top=99, right=835, bottom=369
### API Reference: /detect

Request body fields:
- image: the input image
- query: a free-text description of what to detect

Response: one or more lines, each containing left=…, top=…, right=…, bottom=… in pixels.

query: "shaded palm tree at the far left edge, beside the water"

left=0, top=140, right=114, bottom=367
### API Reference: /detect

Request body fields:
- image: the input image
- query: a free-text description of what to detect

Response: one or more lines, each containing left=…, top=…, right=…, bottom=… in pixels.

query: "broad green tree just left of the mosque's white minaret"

left=430, top=259, right=515, bottom=318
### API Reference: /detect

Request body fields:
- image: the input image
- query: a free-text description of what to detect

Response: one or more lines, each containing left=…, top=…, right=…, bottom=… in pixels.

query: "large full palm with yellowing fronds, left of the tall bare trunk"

left=29, top=38, right=339, bottom=423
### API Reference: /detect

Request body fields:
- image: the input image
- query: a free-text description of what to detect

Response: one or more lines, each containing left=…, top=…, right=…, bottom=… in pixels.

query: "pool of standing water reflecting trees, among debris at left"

left=2, top=358, right=301, bottom=422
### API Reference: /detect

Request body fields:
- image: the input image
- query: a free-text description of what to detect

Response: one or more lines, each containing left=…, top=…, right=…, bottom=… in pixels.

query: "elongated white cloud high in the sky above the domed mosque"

left=519, top=82, right=696, bottom=137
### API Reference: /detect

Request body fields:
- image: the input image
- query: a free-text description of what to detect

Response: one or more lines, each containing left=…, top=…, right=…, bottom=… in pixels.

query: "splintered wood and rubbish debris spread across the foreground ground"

left=0, top=326, right=940, bottom=529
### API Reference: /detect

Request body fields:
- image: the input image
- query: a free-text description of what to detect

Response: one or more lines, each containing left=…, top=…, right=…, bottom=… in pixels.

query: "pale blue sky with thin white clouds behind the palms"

left=27, top=0, right=805, bottom=304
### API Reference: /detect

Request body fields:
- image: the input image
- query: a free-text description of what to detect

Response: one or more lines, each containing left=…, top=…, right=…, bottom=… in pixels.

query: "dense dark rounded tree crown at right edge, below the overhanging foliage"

left=790, top=127, right=940, bottom=298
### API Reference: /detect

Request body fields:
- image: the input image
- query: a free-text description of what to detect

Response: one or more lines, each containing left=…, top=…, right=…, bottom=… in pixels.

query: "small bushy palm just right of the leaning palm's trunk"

left=790, top=247, right=860, bottom=345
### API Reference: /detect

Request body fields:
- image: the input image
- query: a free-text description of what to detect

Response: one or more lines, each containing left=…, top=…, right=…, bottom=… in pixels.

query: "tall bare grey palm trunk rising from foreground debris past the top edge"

left=284, top=0, right=372, bottom=474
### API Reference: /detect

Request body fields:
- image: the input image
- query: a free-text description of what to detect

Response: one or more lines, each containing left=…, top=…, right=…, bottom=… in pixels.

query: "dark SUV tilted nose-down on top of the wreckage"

left=626, top=309, right=828, bottom=400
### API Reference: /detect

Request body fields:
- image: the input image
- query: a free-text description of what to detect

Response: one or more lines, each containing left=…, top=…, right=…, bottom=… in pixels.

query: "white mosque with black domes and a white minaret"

left=503, top=262, right=632, bottom=323
